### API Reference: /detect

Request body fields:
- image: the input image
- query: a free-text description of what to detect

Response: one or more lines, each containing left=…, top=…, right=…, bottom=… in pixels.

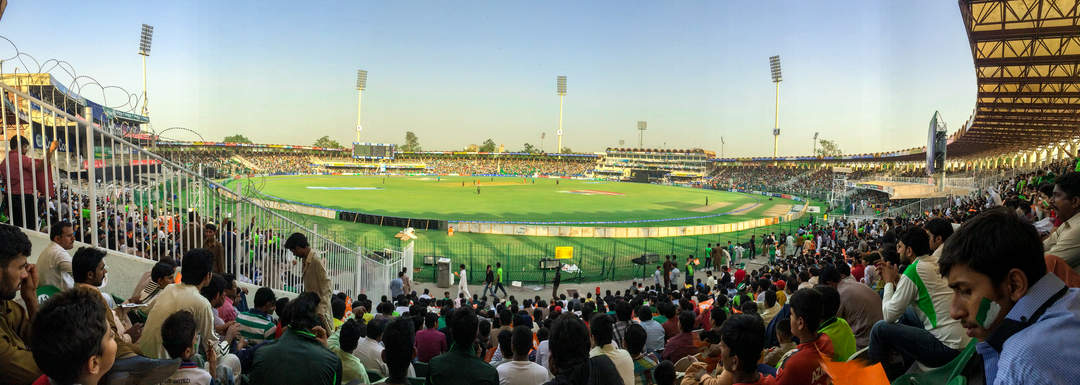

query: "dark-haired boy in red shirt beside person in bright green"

left=775, top=289, right=833, bottom=385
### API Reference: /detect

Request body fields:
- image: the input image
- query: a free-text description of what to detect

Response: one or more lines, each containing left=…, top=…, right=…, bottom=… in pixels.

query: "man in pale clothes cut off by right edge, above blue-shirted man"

left=1042, top=172, right=1080, bottom=273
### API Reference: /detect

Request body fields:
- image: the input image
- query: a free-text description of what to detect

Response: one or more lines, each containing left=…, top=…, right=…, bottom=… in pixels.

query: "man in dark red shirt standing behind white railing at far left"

left=0, top=135, right=58, bottom=230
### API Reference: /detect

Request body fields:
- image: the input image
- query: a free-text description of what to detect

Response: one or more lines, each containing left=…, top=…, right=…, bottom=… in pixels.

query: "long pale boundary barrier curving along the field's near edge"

left=448, top=203, right=809, bottom=238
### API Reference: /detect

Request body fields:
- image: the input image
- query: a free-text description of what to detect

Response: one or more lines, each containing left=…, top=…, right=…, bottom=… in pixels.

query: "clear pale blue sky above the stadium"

left=0, top=0, right=975, bottom=156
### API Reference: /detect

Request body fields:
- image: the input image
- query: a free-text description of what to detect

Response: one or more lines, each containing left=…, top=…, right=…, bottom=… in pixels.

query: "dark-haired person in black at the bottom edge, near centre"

left=544, top=314, right=622, bottom=385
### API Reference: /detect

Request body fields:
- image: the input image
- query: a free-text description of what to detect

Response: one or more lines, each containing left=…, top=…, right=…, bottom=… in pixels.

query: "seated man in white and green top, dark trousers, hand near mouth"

left=867, top=228, right=968, bottom=379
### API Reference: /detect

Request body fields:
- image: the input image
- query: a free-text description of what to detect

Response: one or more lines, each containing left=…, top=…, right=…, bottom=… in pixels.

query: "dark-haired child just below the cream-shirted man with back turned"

left=161, top=310, right=217, bottom=385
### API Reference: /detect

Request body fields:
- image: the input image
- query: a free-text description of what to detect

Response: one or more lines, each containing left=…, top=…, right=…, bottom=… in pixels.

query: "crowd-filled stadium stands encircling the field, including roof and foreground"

left=0, top=0, right=1080, bottom=385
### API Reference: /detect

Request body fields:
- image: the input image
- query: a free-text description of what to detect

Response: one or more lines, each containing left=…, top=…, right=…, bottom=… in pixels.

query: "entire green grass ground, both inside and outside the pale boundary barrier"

left=221, top=176, right=810, bottom=283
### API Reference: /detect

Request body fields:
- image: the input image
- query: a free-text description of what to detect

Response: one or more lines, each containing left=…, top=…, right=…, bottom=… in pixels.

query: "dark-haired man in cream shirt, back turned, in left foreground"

left=138, top=249, right=218, bottom=358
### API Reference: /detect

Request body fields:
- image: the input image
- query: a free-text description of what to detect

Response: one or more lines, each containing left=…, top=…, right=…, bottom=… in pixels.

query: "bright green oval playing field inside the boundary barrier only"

left=240, top=175, right=796, bottom=227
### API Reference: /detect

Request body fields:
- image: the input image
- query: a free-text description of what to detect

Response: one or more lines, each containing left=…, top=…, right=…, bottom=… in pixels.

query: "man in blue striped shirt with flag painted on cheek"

left=939, top=208, right=1080, bottom=384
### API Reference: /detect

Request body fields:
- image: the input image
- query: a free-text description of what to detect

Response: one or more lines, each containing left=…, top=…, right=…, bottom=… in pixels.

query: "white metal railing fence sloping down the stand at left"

left=0, top=78, right=413, bottom=296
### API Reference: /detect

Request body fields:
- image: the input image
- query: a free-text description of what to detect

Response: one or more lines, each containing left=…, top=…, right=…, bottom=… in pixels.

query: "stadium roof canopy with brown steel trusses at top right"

left=948, top=0, right=1080, bottom=157
